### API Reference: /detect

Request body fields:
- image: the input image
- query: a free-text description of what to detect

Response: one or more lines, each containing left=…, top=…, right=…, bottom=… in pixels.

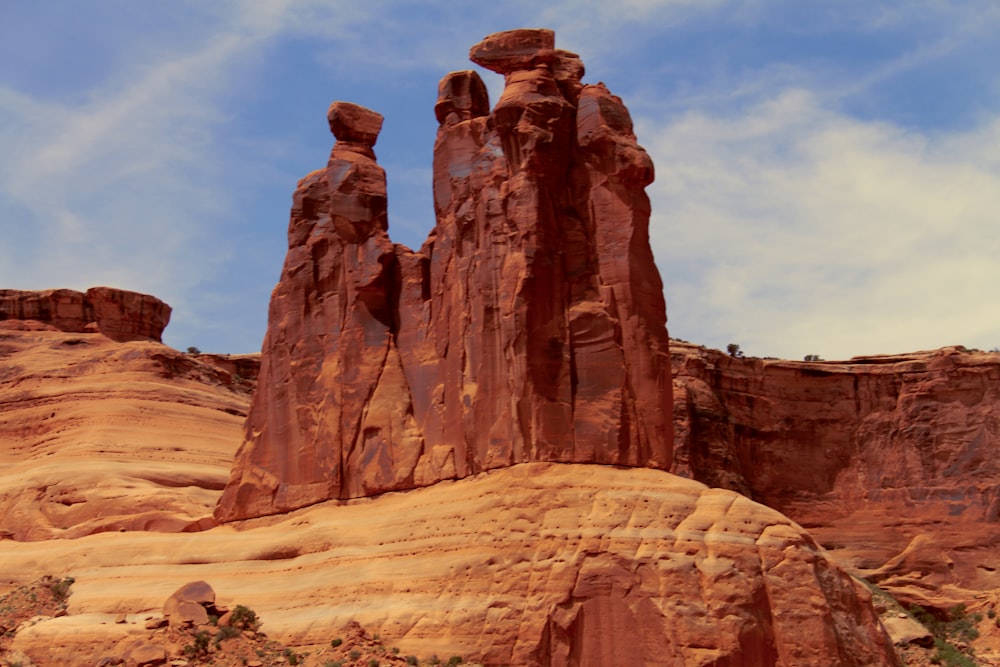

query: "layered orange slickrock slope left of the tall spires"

left=0, top=330, right=256, bottom=540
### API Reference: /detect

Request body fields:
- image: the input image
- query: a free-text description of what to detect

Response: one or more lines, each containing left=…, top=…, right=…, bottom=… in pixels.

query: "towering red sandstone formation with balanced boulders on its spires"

left=216, top=30, right=672, bottom=520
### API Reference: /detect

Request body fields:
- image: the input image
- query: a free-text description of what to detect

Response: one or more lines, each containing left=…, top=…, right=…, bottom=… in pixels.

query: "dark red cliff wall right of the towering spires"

left=672, top=341, right=1000, bottom=610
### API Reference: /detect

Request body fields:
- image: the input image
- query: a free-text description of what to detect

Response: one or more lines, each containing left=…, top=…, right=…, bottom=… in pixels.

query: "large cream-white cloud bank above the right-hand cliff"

left=639, top=90, right=1000, bottom=358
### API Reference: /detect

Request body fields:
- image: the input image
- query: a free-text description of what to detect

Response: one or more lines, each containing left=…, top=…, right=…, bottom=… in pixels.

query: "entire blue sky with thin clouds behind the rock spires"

left=0, top=0, right=1000, bottom=359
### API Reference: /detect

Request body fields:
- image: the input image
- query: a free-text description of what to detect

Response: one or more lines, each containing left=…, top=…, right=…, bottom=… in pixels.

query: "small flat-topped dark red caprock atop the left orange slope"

left=0, top=287, right=171, bottom=342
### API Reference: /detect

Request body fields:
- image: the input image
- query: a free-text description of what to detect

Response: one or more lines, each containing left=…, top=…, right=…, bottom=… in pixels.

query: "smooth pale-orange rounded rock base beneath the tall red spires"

left=0, top=463, right=898, bottom=667
